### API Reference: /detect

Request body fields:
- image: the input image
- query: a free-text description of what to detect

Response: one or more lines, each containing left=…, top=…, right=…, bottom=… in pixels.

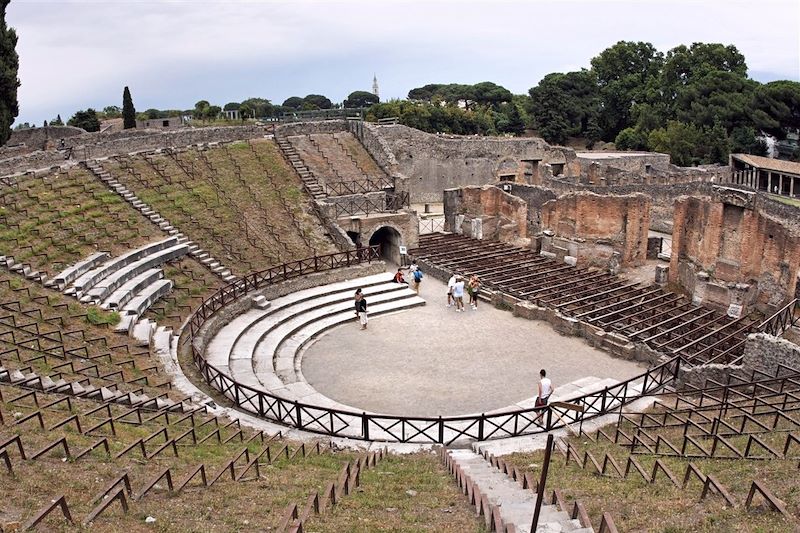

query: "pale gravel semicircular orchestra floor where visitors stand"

left=302, top=270, right=645, bottom=416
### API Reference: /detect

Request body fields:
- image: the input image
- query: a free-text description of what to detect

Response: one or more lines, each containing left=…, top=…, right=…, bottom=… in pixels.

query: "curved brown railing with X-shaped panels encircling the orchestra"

left=181, top=252, right=682, bottom=445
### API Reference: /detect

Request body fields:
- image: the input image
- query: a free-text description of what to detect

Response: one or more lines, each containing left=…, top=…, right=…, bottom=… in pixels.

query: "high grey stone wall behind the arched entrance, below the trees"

left=372, top=125, right=575, bottom=202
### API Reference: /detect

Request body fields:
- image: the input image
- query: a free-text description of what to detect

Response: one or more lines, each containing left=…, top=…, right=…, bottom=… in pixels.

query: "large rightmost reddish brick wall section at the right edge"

left=669, top=187, right=800, bottom=317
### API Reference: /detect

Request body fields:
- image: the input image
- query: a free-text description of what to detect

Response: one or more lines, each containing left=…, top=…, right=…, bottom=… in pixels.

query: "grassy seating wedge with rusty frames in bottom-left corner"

left=0, top=376, right=386, bottom=531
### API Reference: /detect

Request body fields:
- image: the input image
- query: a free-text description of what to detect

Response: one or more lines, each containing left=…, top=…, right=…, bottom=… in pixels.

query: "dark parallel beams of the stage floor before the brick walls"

left=410, top=233, right=761, bottom=364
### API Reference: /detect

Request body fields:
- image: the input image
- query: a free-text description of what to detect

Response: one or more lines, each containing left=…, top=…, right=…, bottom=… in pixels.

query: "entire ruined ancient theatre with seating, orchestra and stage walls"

left=0, top=113, right=800, bottom=531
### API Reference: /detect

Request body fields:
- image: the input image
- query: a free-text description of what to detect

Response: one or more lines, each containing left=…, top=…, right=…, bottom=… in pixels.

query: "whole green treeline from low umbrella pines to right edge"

left=378, top=41, right=800, bottom=165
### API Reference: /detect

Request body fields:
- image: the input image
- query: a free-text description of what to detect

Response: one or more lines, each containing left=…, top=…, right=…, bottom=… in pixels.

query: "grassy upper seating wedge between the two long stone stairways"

left=104, top=140, right=332, bottom=275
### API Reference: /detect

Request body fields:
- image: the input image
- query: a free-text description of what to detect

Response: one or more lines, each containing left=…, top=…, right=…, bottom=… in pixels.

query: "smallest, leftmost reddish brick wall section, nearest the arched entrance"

left=444, top=185, right=529, bottom=244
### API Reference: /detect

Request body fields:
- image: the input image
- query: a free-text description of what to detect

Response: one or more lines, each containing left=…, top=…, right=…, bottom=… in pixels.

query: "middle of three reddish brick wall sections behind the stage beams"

left=541, top=192, right=650, bottom=266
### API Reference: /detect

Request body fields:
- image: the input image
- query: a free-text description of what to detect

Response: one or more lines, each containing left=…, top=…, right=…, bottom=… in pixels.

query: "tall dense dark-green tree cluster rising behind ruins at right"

left=530, top=41, right=788, bottom=165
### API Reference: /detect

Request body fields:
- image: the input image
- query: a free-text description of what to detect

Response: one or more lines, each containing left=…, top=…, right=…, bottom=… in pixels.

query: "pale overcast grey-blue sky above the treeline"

left=6, top=0, right=800, bottom=124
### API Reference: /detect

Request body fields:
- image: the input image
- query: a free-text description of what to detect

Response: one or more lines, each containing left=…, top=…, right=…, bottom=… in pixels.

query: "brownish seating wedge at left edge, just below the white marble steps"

left=0, top=274, right=195, bottom=403
